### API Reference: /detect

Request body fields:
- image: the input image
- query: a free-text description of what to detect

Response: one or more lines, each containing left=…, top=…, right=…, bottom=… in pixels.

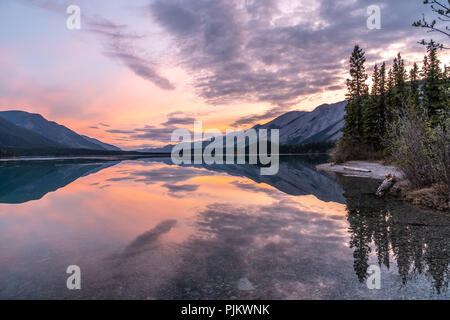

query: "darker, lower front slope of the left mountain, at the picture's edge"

left=0, top=118, right=61, bottom=148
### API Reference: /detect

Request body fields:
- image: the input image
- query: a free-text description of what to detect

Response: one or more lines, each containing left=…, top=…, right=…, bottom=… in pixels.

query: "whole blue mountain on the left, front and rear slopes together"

left=0, top=110, right=120, bottom=151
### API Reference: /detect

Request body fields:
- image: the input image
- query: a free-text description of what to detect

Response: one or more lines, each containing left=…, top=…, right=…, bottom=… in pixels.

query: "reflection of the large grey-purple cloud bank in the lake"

left=158, top=201, right=356, bottom=299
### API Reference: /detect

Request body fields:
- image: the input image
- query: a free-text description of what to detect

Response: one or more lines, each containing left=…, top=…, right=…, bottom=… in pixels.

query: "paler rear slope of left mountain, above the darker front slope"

left=0, top=111, right=120, bottom=151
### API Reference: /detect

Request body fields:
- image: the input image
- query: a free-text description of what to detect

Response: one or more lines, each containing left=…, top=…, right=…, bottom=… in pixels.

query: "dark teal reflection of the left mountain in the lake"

left=0, top=161, right=117, bottom=203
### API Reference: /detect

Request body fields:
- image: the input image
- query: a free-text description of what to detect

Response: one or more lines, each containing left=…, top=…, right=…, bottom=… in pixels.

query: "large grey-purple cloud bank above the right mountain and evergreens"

left=149, top=0, right=436, bottom=107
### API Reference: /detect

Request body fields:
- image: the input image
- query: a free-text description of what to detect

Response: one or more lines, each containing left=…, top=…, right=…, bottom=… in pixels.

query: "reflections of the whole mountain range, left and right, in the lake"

left=0, top=158, right=345, bottom=203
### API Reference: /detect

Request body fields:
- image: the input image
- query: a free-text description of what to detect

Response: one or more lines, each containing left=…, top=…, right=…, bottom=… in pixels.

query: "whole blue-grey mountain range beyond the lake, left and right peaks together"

left=0, top=101, right=347, bottom=153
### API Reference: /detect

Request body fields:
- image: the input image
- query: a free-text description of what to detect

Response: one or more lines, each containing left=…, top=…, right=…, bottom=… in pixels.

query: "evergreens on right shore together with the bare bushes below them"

left=333, top=41, right=450, bottom=202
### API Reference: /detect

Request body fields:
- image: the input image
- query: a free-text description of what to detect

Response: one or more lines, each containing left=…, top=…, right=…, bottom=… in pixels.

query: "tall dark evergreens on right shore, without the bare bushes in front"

left=335, top=42, right=450, bottom=161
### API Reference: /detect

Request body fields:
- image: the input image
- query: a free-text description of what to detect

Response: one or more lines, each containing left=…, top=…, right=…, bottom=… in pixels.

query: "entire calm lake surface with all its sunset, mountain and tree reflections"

left=0, top=158, right=450, bottom=299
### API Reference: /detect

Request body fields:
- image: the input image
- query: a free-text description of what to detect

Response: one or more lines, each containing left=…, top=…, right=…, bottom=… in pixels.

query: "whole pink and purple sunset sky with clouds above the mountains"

left=0, top=0, right=450, bottom=150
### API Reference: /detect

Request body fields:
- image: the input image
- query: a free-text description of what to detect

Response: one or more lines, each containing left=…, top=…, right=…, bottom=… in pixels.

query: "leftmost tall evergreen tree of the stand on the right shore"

left=343, top=45, right=368, bottom=145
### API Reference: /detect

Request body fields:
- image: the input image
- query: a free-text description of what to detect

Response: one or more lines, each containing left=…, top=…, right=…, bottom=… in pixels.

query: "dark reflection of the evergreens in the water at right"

left=338, top=176, right=450, bottom=294
